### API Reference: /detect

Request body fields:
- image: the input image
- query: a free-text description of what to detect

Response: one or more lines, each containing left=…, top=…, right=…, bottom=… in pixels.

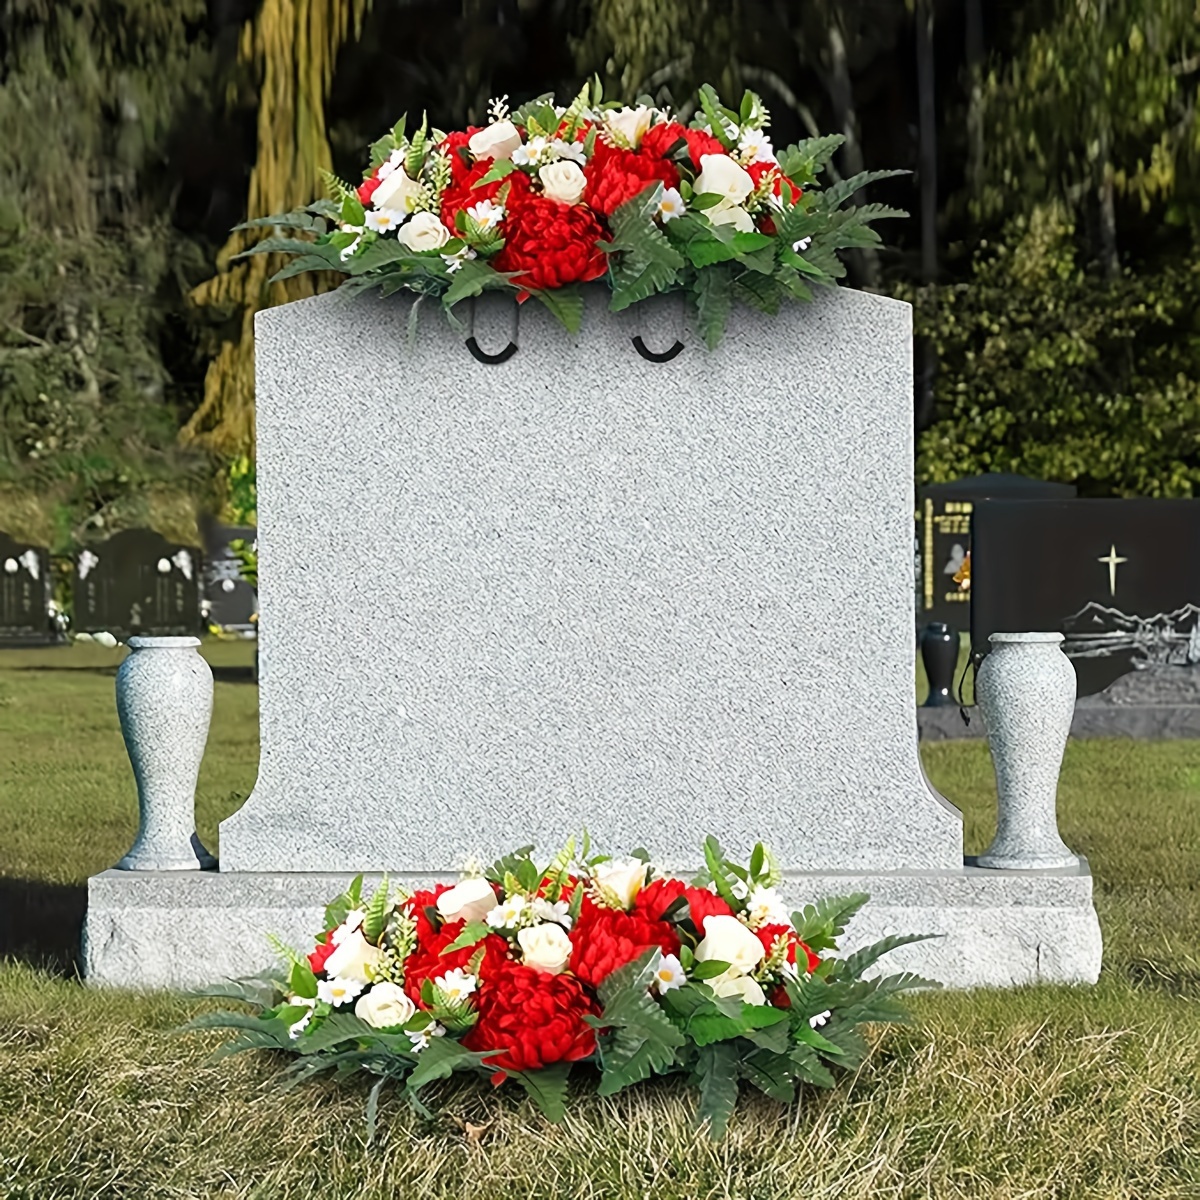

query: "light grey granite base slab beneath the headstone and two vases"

left=83, top=859, right=1102, bottom=989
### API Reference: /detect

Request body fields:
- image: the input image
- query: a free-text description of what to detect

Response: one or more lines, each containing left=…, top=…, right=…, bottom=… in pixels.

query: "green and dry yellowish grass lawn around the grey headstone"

left=0, top=641, right=1200, bottom=1200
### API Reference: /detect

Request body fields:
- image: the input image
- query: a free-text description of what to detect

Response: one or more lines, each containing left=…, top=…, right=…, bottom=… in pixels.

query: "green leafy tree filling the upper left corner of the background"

left=0, top=0, right=211, bottom=536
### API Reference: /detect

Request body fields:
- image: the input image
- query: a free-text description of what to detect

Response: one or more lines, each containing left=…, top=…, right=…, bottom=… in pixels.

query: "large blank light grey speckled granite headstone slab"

left=221, top=288, right=962, bottom=872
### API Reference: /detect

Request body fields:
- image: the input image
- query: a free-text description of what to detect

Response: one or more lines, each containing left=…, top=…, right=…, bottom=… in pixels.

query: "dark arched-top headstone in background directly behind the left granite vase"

left=74, top=529, right=203, bottom=638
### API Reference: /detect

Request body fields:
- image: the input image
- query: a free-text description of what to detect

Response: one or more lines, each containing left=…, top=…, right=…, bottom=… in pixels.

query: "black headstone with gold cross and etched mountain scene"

left=971, top=500, right=1200, bottom=696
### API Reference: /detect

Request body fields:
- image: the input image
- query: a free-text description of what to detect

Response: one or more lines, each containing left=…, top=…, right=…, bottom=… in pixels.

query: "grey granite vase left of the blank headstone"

left=116, top=637, right=216, bottom=871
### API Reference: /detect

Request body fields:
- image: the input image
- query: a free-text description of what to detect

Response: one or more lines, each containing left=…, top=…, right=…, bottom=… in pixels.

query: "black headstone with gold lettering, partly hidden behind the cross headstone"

left=917, top=472, right=1075, bottom=632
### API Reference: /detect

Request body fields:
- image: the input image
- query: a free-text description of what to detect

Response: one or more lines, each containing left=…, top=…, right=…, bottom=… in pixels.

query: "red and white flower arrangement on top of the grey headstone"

left=239, top=80, right=905, bottom=347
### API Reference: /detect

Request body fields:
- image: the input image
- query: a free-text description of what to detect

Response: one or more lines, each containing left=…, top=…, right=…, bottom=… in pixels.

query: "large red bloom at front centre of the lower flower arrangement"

left=465, top=955, right=600, bottom=1084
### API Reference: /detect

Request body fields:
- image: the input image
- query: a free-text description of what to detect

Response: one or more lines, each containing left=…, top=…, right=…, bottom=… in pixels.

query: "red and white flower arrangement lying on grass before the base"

left=188, top=838, right=936, bottom=1138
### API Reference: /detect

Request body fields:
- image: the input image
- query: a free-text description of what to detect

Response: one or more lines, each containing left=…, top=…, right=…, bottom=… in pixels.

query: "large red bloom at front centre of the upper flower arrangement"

left=481, top=196, right=608, bottom=289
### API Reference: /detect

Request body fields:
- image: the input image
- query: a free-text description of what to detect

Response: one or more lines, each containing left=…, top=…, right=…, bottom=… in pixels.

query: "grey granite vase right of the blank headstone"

left=976, top=634, right=1079, bottom=870
